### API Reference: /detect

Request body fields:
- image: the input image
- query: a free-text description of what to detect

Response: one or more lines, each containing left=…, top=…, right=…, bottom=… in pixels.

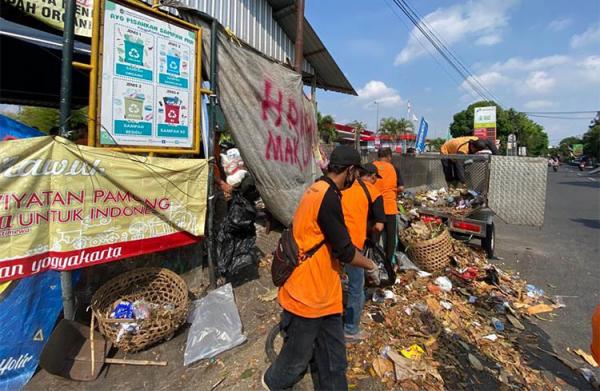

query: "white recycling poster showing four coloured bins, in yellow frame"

left=99, top=1, right=200, bottom=148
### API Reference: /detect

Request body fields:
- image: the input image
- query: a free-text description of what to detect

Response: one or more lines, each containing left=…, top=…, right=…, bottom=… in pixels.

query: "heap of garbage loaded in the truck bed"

left=398, top=187, right=485, bottom=216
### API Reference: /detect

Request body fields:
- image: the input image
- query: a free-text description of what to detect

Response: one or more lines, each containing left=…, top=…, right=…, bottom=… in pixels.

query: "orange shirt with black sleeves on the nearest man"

left=278, top=180, right=356, bottom=318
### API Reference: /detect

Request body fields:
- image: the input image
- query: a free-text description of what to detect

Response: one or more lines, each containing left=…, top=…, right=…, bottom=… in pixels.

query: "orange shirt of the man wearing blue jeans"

left=342, top=181, right=381, bottom=250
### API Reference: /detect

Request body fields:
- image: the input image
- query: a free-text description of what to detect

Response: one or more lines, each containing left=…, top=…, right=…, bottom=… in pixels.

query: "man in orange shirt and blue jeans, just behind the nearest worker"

left=342, top=163, right=385, bottom=342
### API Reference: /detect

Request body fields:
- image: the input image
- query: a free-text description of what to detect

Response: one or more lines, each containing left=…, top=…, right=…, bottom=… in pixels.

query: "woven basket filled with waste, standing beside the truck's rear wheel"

left=403, top=229, right=452, bottom=273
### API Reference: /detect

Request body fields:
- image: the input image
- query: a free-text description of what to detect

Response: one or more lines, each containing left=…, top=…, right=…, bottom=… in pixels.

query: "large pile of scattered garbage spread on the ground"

left=348, top=240, right=576, bottom=390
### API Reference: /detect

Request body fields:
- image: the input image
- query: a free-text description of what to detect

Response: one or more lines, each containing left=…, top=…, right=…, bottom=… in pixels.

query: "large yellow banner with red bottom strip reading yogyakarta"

left=0, top=137, right=208, bottom=283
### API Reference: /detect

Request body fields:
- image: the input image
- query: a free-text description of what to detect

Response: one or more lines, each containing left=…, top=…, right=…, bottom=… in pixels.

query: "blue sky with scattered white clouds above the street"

left=306, top=0, right=600, bottom=145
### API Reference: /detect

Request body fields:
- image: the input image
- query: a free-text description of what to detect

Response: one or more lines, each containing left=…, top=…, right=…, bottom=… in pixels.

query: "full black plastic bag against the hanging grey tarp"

left=216, top=192, right=258, bottom=282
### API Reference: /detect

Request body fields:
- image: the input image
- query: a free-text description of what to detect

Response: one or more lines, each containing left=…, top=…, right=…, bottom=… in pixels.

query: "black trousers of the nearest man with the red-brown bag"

left=265, top=311, right=348, bottom=391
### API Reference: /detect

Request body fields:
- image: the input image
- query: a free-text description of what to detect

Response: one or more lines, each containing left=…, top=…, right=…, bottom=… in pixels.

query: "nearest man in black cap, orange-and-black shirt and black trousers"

left=262, top=146, right=379, bottom=390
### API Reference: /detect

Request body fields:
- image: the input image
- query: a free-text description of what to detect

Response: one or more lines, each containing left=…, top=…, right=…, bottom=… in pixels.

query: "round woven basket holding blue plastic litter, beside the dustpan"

left=92, top=268, right=189, bottom=352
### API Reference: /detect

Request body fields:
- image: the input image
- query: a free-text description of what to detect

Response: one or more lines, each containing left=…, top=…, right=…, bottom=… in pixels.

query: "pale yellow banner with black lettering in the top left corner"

left=5, top=0, right=94, bottom=37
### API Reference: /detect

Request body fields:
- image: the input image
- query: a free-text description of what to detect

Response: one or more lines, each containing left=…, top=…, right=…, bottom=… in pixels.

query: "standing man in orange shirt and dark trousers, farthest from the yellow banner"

left=373, top=148, right=404, bottom=283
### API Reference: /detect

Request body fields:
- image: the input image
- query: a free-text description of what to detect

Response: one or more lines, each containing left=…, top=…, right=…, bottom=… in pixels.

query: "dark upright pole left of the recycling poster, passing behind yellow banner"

left=59, top=0, right=75, bottom=320
